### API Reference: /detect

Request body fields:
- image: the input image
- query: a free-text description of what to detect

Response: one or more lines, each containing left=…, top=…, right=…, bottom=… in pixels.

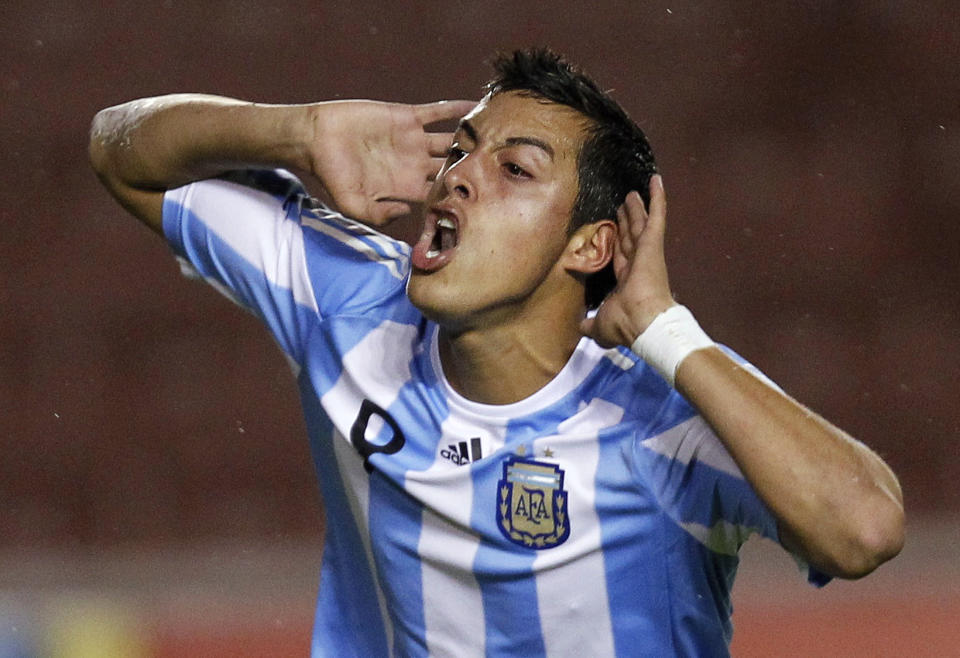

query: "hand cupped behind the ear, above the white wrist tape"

left=580, top=175, right=676, bottom=347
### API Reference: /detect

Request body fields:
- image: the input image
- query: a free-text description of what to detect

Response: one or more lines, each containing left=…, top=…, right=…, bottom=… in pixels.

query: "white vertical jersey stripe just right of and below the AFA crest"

left=533, top=398, right=623, bottom=656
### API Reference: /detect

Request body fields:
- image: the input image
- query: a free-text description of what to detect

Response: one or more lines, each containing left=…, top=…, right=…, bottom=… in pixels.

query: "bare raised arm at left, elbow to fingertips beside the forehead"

left=89, top=94, right=473, bottom=233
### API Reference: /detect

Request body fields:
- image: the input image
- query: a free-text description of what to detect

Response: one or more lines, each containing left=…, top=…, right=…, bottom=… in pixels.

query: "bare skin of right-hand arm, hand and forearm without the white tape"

left=581, top=176, right=904, bottom=578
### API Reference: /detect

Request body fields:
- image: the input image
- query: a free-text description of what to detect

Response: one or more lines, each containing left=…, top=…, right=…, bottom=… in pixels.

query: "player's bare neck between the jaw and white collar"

left=439, top=296, right=585, bottom=404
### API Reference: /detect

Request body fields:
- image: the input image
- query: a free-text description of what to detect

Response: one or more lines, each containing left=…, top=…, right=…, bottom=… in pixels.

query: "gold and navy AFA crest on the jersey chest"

left=497, top=456, right=570, bottom=550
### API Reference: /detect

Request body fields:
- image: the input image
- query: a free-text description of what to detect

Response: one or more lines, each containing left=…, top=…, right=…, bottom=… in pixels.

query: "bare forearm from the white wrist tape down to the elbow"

left=676, top=348, right=903, bottom=577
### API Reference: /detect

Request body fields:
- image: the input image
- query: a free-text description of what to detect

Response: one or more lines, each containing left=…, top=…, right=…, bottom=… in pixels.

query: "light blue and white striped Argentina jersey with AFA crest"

left=163, top=171, right=820, bottom=658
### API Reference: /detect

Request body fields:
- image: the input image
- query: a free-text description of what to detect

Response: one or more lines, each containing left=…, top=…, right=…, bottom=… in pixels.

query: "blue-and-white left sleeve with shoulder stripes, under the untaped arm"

left=163, top=170, right=410, bottom=364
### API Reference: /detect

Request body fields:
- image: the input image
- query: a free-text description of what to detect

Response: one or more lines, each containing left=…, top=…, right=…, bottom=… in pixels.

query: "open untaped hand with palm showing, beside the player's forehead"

left=309, top=101, right=476, bottom=226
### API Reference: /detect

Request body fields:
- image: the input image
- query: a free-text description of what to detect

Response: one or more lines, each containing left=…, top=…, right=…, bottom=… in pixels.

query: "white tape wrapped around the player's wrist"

left=630, top=304, right=714, bottom=386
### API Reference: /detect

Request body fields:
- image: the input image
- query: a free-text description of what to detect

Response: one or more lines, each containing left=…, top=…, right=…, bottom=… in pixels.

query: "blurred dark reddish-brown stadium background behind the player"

left=0, top=0, right=960, bottom=657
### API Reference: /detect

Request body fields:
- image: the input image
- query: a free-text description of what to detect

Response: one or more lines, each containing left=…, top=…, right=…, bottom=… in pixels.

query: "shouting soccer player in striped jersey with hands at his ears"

left=90, top=51, right=903, bottom=657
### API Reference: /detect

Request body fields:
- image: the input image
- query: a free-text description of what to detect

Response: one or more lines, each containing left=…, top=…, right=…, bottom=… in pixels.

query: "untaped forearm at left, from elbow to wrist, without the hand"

left=90, top=94, right=314, bottom=190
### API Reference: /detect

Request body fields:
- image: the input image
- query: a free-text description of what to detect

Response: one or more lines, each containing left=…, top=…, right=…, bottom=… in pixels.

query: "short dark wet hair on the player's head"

left=486, top=48, right=657, bottom=308
